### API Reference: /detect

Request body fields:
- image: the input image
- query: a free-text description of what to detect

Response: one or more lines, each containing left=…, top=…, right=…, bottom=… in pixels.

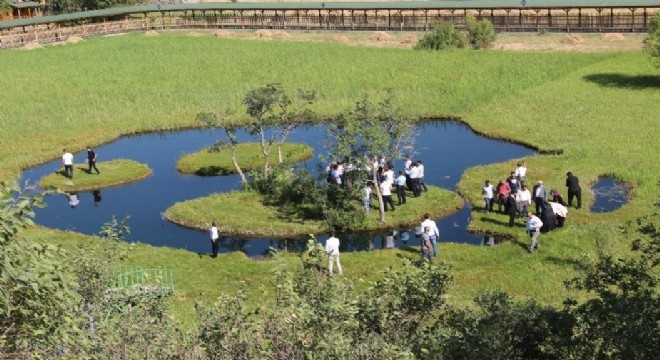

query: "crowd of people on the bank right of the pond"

left=482, top=161, right=582, bottom=252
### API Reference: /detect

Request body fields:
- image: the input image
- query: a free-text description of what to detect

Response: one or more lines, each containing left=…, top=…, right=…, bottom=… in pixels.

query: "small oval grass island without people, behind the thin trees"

left=176, top=143, right=314, bottom=176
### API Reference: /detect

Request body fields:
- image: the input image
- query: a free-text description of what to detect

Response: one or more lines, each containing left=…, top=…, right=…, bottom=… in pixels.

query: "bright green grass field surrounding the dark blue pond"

left=0, top=33, right=660, bottom=323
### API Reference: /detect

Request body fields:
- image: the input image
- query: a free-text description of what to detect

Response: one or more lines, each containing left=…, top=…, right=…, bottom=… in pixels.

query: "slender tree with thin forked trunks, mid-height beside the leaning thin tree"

left=243, top=84, right=316, bottom=177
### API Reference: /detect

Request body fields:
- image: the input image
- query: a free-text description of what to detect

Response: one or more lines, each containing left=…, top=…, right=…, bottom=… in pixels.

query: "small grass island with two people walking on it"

left=39, top=159, right=151, bottom=191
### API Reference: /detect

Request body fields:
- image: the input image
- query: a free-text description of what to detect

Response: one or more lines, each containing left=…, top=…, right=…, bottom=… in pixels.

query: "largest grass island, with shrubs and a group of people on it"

left=164, top=186, right=463, bottom=238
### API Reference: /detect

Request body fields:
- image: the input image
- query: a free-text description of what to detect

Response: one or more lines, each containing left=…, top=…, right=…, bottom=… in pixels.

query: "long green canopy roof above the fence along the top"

left=0, top=0, right=660, bottom=29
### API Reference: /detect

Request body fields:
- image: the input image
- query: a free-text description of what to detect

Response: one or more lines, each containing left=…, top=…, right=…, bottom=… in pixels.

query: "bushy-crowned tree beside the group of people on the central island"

left=327, top=90, right=414, bottom=221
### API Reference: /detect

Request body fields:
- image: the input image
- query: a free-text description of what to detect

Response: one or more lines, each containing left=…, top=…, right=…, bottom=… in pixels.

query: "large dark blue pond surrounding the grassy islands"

left=22, top=121, right=535, bottom=256
